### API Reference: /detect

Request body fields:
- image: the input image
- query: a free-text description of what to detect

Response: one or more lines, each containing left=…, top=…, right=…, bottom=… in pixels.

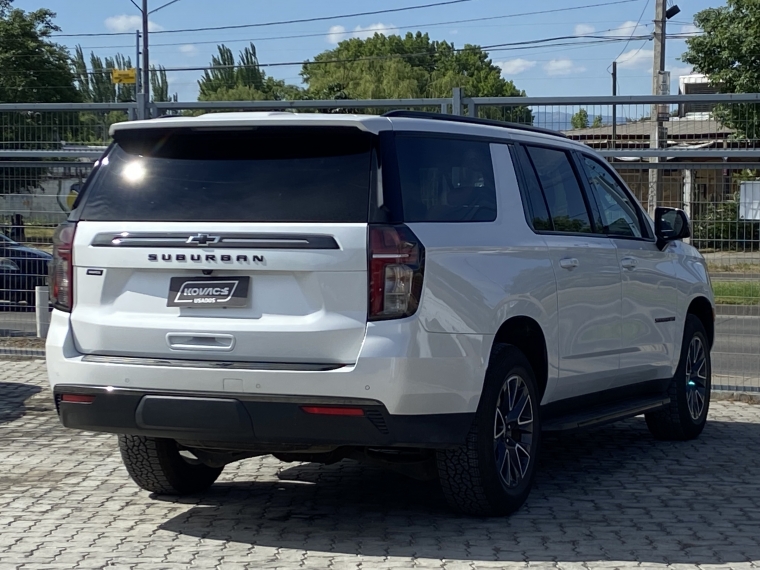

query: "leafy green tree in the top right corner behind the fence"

left=681, top=0, right=760, bottom=139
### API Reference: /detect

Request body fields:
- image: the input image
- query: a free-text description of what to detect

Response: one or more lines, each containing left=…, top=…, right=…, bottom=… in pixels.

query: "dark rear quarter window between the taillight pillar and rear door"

left=396, top=135, right=496, bottom=222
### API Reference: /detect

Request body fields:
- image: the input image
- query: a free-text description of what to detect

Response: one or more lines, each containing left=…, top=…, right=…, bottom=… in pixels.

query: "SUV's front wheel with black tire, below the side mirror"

left=645, top=315, right=712, bottom=441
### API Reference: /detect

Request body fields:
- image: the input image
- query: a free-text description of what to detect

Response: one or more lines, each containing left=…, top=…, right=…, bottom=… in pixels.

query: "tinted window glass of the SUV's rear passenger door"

left=527, top=147, right=591, bottom=233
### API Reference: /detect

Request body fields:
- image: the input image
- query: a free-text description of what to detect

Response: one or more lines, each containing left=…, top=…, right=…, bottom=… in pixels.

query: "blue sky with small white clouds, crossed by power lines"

left=14, top=0, right=724, bottom=101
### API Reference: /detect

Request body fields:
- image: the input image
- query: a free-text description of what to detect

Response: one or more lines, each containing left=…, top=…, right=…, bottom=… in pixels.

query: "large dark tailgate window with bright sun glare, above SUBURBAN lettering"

left=80, top=127, right=373, bottom=222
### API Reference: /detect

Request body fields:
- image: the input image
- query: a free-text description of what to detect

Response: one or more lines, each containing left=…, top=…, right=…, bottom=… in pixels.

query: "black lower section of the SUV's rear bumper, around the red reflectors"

left=54, top=384, right=474, bottom=452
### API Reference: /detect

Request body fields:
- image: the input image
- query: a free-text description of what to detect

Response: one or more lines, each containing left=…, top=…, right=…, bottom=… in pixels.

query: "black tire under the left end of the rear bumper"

left=119, top=435, right=223, bottom=495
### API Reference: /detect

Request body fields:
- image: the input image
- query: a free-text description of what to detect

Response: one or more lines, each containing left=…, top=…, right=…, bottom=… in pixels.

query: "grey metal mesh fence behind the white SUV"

left=0, top=94, right=760, bottom=391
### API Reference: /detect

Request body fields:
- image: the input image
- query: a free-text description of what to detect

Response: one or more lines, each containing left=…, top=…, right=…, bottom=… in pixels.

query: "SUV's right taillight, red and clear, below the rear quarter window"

left=369, top=225, right=425, bottom=321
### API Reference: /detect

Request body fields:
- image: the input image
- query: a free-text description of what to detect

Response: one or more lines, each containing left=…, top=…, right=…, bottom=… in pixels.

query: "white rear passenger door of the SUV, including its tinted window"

left=518, top=146, right=622, bottom=400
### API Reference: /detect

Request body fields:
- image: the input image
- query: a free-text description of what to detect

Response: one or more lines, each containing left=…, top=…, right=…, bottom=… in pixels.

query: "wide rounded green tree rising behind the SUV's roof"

left=301, top=32, right=532, bottom=123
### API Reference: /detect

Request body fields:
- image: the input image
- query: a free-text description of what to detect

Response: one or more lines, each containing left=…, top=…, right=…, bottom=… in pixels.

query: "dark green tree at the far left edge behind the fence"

left=0, top=0, right=80, bottom=193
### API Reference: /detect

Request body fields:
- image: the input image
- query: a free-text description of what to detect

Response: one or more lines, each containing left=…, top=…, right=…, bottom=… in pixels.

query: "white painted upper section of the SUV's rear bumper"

left=46, top=310, right=493, bottom=416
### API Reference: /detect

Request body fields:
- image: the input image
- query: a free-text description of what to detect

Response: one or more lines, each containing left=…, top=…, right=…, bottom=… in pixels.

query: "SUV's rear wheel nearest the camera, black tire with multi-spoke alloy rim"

left=436, top=344, right=541, bottom=516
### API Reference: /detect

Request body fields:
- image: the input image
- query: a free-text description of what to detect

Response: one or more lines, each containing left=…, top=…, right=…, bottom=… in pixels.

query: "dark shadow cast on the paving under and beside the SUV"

left=154, top=418, right=760, bottom=564
